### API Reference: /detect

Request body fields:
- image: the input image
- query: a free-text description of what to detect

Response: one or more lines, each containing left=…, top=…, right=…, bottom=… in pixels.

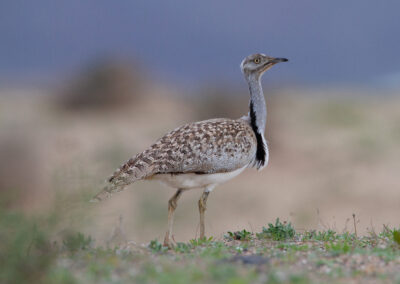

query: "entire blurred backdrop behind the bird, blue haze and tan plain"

left=0, top=0, right=400, bottom=243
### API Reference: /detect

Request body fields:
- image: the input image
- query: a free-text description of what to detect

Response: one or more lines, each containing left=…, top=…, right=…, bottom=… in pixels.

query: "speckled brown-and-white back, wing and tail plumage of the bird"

left=91, top=118, right=257, bottom=200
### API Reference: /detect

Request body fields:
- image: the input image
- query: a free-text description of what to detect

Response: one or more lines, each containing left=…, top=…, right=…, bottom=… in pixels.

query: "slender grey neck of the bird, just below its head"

left=247, top=76, right=267, bottom=136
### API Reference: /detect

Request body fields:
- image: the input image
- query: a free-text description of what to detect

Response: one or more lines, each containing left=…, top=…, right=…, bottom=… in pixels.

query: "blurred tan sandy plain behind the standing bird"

left=0, top=87, right=400, bottom=245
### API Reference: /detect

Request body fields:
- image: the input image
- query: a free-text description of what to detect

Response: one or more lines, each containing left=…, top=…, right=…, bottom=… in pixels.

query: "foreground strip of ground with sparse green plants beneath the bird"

left=0, top=213, right=400, bottom=284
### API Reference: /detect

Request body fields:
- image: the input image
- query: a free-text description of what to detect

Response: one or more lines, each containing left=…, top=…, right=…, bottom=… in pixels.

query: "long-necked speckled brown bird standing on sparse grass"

left=91, top=53, right=288, bottom=248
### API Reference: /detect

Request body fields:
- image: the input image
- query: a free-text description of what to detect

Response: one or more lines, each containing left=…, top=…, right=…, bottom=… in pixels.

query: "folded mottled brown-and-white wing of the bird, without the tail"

left=150, top=119, right=256, bottom=173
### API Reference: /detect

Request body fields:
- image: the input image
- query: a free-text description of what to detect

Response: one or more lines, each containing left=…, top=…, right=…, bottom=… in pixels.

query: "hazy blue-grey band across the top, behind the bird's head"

left=0, top=0, right=400, bottom=84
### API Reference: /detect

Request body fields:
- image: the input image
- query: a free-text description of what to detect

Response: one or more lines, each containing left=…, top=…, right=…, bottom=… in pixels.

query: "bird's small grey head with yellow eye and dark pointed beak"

left=240, top=53, right=288, bottom=78
